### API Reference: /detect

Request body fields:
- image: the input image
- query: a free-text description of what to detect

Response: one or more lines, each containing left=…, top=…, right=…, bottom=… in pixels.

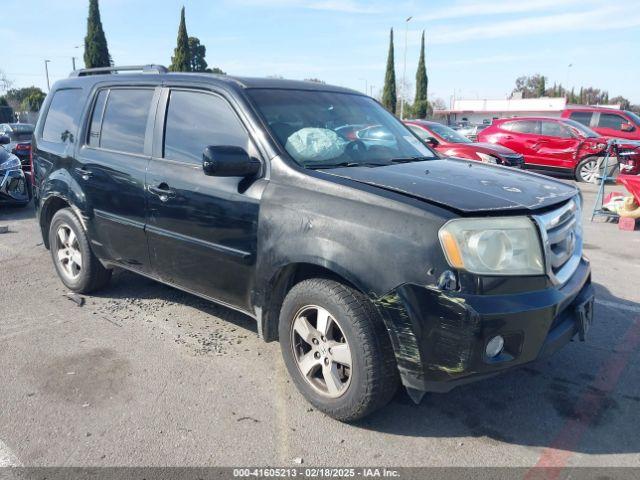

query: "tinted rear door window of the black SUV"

left=100, top=89, right=153, bottom=154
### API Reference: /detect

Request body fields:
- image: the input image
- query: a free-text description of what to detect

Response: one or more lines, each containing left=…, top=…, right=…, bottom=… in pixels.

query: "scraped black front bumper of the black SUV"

left=376, top=258, right=594, bottom=398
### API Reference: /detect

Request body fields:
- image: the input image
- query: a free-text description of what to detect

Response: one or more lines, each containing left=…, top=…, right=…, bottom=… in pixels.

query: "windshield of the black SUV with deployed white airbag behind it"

left=248, top=89, right=438, bottom=168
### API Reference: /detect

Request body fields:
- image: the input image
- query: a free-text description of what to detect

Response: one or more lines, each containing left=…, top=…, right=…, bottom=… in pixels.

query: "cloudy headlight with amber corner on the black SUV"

left=438, top=217, right=545, bottom=275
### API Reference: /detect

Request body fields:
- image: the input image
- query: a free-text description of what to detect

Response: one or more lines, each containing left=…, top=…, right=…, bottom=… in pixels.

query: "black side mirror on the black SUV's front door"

left=202, top=145, right=261, bottom=177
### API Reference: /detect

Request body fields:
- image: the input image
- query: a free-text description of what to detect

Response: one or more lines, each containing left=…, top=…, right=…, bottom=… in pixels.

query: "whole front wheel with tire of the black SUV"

left=279, top=278, right=399, bottom=422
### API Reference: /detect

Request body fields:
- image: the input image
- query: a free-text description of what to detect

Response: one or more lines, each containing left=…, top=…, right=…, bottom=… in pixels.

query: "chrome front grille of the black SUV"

left=533, top=199, right=582, bottom=284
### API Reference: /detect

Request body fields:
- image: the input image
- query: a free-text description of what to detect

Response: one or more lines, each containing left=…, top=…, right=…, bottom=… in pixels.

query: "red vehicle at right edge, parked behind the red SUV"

left=560, top=106, right=640, bottom=140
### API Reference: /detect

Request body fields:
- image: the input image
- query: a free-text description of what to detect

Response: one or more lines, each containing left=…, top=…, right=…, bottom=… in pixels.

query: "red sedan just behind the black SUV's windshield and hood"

left=404, top=120, right=524, bottom=168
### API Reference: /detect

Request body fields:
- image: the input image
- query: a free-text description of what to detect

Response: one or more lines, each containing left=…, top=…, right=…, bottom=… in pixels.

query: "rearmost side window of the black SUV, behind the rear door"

left=42, top=88, right=82, bottom=143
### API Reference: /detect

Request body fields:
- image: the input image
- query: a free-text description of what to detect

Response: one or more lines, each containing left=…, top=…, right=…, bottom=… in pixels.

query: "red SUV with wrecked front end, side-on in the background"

left=479, top=117, right=640, bottom=182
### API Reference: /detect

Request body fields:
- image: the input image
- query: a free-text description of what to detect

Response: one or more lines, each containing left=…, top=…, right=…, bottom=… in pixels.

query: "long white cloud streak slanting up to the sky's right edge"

left=427, top=6, right=640, bottom=44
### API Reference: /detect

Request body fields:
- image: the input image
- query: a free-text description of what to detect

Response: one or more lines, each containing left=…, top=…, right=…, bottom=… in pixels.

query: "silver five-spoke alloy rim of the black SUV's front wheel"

left=291, top=305, right=352, bottom=398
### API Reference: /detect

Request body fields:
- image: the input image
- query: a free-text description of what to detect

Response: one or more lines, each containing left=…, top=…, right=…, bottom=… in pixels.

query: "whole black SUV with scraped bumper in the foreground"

left=33, top=66, right=593, bottom=421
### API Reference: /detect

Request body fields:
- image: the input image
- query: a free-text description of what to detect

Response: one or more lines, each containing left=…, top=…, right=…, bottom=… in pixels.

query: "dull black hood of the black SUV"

left=323, top=159, right=578, bottom=213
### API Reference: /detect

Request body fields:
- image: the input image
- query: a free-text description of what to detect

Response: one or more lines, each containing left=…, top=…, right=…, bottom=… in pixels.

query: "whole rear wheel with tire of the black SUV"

left=49, top=208, right=111, bottom=293
